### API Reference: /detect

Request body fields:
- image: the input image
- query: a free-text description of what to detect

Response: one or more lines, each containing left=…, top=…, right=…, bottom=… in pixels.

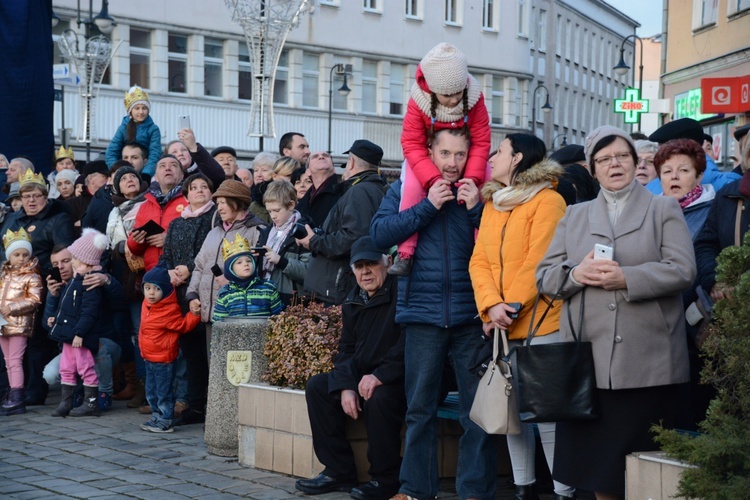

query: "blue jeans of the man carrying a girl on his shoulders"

left=399, top=325, right=497, bottom=499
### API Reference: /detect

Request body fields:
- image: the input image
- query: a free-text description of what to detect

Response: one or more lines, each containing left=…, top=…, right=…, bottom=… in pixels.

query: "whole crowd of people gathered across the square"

left=0, top=43, right=750, bottom=500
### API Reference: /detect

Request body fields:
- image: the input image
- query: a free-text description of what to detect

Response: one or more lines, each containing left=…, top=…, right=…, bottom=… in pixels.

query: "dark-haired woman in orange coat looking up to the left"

left=469, top=134, right=575, bottom=499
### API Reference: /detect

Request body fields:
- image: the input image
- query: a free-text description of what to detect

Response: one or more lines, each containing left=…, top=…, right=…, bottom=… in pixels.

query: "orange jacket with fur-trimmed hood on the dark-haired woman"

left=469, top=160, right=565, bottom=339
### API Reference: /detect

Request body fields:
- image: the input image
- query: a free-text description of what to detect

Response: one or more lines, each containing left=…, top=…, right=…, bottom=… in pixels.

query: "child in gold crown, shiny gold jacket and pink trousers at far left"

left=0, top=228, right=43, bottom=415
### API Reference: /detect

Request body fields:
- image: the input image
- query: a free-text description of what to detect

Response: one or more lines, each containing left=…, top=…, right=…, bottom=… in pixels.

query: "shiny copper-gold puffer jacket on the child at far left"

left=0, top=258, right=44, bottom=337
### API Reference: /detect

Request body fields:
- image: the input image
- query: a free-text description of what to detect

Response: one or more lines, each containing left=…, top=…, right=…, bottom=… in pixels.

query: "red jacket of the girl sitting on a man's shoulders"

left=401, top=67, right=492, bottom=187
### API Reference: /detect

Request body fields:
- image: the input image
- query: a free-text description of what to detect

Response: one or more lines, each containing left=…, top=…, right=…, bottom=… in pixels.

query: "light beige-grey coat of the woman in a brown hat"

left=185, top=212, right=263, bottom=323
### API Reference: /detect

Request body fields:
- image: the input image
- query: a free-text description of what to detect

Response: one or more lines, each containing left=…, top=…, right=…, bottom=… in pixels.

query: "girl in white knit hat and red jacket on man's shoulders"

left=388, top=43, right=491, bottom=276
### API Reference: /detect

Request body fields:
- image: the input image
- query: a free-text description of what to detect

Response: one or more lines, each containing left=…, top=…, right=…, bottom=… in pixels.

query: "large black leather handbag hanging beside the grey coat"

left=514, top=276, right=598, bottom=423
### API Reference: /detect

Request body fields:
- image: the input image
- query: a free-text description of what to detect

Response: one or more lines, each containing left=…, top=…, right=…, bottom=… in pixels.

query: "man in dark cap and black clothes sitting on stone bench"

left=296, top=236, right=406, bottom=500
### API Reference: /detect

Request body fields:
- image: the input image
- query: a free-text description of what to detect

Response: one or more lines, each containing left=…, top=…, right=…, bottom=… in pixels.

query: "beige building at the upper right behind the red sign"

left=662, top=0, right=750, bottom=170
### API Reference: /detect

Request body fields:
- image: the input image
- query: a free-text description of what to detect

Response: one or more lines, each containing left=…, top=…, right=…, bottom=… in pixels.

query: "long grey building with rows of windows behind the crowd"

left=53, top=0, right=635, bottom=165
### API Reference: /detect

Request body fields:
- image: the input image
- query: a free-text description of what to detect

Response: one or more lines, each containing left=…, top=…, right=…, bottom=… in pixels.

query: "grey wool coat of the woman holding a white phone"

left=536, top=183, right=696, bottom=389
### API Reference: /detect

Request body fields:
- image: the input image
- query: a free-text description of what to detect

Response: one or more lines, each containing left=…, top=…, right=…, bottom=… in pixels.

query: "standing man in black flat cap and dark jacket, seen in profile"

left=298, top=139, right=388, bottom=304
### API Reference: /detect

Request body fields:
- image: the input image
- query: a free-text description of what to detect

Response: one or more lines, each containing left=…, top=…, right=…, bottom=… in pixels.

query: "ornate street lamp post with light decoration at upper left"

left=52, top=0, right=119, bottom=161
